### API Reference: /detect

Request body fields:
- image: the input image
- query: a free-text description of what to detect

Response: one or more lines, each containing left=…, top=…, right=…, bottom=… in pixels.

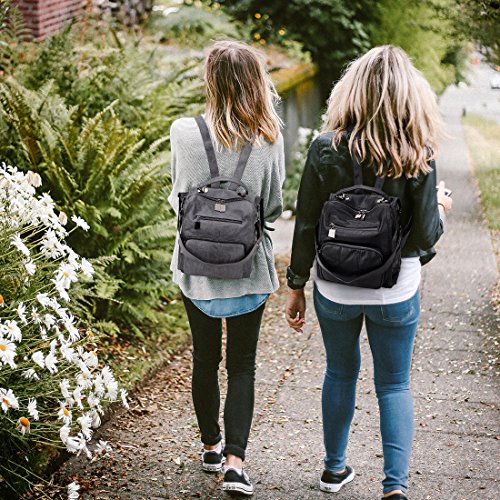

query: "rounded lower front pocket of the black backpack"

left=319, top=241, right=384, bottom=276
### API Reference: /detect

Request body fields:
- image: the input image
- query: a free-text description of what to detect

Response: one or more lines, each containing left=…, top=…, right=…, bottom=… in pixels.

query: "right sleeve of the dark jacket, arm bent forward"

left=409, top=160, right=443, bottom=263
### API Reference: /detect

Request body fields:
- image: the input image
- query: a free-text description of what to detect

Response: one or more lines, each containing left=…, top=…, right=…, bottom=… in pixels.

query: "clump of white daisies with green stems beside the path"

left=0, top=164, right=127, bottom=491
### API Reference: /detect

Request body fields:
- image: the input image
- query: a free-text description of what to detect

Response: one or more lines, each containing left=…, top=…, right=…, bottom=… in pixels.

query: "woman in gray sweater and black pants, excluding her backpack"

left=169, top=41, right=285, bottom=495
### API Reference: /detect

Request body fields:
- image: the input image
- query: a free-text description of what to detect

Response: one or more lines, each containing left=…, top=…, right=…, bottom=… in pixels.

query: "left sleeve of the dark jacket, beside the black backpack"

left=287, top=140, right=324, bottom=288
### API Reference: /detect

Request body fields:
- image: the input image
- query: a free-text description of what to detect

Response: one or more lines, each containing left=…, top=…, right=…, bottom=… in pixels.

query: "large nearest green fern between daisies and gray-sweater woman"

left=0, top=79, right=184, bottom=333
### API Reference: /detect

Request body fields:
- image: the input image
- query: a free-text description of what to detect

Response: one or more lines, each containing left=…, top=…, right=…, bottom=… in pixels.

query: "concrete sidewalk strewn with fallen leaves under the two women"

left=53, top=85, right=500, bottom=500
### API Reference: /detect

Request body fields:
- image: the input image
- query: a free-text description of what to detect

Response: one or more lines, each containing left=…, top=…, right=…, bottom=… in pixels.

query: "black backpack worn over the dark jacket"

left=316, top=151, right=411, bottom=288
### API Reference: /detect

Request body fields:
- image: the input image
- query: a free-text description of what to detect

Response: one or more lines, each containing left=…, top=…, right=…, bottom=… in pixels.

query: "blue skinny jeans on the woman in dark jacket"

left=314, top=287, right=420, bottom=493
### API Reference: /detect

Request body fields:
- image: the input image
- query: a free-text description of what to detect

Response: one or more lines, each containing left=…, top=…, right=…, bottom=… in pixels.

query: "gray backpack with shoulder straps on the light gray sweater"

left=178, top=116, right=264, bottom=279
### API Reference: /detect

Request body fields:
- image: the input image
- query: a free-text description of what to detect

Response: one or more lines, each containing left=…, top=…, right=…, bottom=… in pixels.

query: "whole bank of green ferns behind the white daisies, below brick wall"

left=0, top=20, right=203, bottom=335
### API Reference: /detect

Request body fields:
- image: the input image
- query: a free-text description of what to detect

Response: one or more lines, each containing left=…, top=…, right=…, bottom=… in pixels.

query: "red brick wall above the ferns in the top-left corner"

left=15, top=0, right=87, bottom=38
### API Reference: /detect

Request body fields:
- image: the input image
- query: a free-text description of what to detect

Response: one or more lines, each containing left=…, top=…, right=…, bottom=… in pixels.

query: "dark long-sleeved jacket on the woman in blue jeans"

left=288, top=132, right=443, bottom=288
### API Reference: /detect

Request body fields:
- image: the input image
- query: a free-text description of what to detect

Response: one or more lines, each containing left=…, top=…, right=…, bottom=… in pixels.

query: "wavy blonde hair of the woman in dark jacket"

left=323, top=45, right=442, bottom=177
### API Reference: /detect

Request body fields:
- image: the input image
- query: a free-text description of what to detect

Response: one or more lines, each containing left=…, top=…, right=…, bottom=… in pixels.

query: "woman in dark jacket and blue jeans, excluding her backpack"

left=286, top=45, right=451, bottom=500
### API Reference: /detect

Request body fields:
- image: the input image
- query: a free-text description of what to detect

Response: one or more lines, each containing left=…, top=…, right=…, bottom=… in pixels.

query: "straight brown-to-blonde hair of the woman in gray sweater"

left=205, top=41, right=281, bottom=148
